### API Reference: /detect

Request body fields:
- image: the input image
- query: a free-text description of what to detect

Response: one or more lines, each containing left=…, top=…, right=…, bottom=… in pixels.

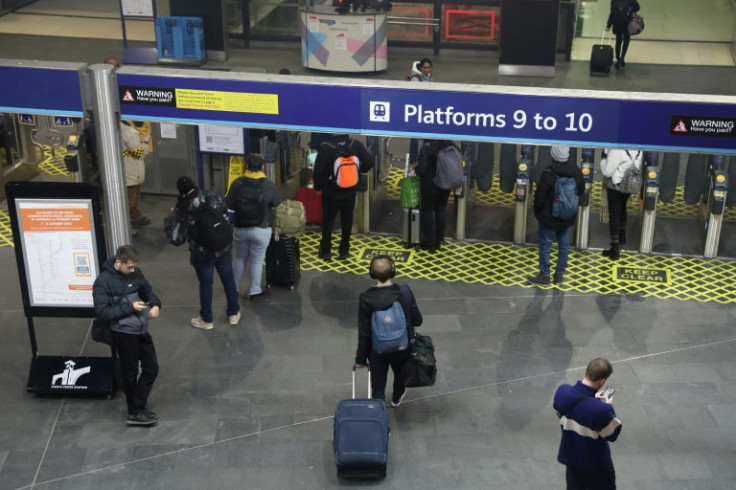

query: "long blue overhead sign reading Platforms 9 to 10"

left=118, top=74, right=736, bottom=153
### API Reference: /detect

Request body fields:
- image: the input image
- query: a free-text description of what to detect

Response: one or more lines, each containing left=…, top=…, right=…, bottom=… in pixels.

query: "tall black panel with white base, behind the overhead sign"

left=498, top=0, right=560, bottom=77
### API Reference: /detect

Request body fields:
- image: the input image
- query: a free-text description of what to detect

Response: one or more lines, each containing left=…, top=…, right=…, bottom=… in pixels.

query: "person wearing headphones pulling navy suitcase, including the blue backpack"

left=355, top=255, right=424, bottom=407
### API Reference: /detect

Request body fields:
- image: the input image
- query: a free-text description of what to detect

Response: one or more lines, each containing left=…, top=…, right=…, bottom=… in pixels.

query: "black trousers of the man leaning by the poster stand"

left=112, top=332, right=158, bottom=414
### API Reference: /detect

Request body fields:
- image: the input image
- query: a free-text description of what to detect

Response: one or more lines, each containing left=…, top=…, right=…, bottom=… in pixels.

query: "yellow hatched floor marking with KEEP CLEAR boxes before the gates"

left=300, top=231, right=736, bottom=304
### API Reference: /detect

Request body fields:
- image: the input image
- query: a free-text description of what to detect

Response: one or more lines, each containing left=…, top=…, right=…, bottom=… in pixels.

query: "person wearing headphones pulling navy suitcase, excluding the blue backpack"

left=355, top=255, right=424, bottom=407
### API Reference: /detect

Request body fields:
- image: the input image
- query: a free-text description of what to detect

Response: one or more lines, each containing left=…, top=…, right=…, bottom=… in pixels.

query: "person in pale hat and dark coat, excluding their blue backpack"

left=528, top=146, right=585, bottom=286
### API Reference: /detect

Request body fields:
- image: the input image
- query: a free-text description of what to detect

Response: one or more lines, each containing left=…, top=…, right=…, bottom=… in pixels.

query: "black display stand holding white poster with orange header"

left=5, top=182, right=115, bottom=398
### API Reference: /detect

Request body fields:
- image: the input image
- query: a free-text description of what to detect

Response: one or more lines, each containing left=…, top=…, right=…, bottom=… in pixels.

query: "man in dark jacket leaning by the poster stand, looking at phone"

left=92, top=245, right=161, bottom=425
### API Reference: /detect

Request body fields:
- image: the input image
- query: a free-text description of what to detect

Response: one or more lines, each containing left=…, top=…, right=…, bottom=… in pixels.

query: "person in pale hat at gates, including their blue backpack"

left=528, top=146, right=585, bottom=286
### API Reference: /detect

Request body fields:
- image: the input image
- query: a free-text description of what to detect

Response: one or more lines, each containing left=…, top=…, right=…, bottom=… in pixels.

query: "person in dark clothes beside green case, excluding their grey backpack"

left=416, top=140, right=452, bottom=253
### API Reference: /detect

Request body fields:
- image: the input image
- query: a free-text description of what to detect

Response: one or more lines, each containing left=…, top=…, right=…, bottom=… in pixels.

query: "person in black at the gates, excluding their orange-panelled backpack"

left=313, top=134, right=374, bottom=261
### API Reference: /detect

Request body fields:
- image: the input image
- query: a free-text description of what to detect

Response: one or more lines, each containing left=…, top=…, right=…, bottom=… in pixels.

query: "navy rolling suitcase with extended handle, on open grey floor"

left=332, top=366, right=389, bottom=479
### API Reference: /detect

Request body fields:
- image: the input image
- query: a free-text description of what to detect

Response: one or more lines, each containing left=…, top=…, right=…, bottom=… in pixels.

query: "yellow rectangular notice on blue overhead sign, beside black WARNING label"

left=176, top=88, right=279, bottom=114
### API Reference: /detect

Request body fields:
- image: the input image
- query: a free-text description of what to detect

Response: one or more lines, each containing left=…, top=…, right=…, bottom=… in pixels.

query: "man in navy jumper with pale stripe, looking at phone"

left=552, top=358, right=621, bottom=490
